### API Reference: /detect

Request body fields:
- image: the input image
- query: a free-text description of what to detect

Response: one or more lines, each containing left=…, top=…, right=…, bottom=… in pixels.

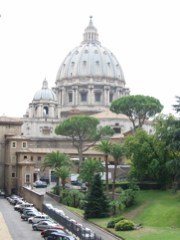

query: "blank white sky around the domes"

left=0, top=0, right=180, bottom=117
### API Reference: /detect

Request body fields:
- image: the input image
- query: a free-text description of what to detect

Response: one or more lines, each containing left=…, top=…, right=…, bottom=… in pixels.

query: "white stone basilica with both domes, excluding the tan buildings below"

left=22, top=17, right=152, bottom=137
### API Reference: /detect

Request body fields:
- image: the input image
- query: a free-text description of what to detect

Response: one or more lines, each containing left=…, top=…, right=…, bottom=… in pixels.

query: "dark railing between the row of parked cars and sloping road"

left=42, top=204, right=103, bottom=240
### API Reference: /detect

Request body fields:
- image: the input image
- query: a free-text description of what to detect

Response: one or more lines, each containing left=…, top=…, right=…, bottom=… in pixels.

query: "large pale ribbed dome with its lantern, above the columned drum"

left=56, top=17, right=124, bottom=81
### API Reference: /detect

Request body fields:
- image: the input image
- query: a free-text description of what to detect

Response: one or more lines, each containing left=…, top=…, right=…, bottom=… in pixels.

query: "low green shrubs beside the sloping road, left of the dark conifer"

left=62, top=189, right=85, bottom=208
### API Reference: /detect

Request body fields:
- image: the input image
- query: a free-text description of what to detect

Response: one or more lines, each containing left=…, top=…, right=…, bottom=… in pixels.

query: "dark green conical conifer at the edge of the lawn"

left=84, top=174, right=110, bottom=219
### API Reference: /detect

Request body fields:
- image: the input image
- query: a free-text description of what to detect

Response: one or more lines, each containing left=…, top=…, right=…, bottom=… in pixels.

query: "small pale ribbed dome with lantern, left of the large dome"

left=33, top=79, right=57, bottom=101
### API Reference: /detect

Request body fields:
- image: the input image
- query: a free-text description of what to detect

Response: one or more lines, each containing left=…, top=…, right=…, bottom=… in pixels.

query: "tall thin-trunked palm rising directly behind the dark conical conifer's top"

left=95, top=140, right=112, bottom=191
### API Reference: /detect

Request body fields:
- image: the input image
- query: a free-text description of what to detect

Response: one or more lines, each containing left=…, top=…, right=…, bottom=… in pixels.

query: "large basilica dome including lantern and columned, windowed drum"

left=54, top=17, right=130, bottom=117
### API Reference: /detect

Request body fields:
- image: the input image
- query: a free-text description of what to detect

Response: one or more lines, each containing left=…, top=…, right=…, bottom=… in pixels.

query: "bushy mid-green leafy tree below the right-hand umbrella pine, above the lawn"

left=124, top=129, right=165, bottom=181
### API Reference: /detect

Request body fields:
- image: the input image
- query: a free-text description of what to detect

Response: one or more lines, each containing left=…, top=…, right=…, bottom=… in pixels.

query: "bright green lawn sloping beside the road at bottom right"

left=67, top=191, right=180, bottom=240
